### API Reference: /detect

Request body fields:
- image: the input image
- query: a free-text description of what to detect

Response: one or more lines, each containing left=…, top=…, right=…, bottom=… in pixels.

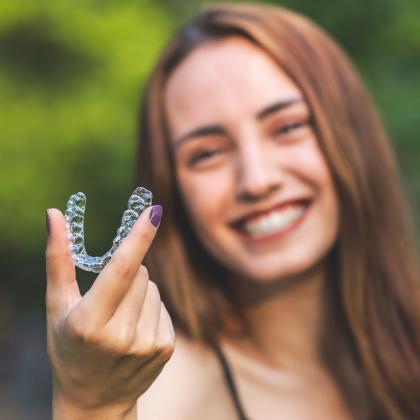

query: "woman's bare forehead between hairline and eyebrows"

left=165, top=37, right=302, bottom=134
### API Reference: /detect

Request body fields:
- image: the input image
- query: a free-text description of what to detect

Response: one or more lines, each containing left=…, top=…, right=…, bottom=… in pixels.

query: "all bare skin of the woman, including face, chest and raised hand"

left=47, top=38, right=350, bottom=420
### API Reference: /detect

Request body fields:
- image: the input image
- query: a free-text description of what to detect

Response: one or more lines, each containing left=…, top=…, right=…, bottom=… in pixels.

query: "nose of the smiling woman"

left=236, top=147, right=282, bottom=201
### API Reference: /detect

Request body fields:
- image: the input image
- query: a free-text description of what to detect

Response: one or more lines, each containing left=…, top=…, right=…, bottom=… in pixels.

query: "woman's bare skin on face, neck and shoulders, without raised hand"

left=139, top=38, right=350, bottom=420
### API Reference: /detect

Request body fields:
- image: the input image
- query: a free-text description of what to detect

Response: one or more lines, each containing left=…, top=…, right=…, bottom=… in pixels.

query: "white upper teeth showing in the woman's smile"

left=243, top=206, right=305, bottom=236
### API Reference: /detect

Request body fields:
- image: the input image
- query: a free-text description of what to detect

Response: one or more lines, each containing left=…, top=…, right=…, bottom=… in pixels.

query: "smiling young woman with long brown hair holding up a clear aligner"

left=47, top=5, right=420, bottom=420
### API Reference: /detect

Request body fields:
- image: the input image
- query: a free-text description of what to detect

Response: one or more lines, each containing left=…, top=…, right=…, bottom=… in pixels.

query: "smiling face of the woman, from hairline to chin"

left=165, top=37, right=338, bottom=281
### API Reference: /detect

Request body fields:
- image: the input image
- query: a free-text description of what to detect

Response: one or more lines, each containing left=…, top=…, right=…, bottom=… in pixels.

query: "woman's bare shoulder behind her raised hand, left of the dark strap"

left=138, top=333, right=230, bottom=420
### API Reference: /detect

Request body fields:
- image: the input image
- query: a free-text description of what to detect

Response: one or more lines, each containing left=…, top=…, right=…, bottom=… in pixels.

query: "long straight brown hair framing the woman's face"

left=137, top=5, right=420, bottom=420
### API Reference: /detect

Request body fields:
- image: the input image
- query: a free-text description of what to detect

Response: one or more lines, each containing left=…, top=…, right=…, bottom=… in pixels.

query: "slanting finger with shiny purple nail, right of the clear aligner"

left=81, top=206, right=162, bottom=323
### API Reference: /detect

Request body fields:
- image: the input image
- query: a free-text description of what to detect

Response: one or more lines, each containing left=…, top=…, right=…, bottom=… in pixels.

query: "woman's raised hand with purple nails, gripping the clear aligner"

left=46, top=208, right=175, bottom=420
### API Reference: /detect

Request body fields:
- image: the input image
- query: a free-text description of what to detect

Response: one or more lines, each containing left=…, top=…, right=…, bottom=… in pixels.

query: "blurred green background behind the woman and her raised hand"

left=0, top=0, right=420, bottom=419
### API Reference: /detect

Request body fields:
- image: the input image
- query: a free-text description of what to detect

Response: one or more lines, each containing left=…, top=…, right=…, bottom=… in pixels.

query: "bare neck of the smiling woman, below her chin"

left=228, top=267, right=326, bottom=369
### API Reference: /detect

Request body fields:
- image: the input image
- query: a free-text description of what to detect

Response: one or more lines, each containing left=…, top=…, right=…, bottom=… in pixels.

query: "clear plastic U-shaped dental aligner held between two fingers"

left=65, top=187, right=153, bottom=273
